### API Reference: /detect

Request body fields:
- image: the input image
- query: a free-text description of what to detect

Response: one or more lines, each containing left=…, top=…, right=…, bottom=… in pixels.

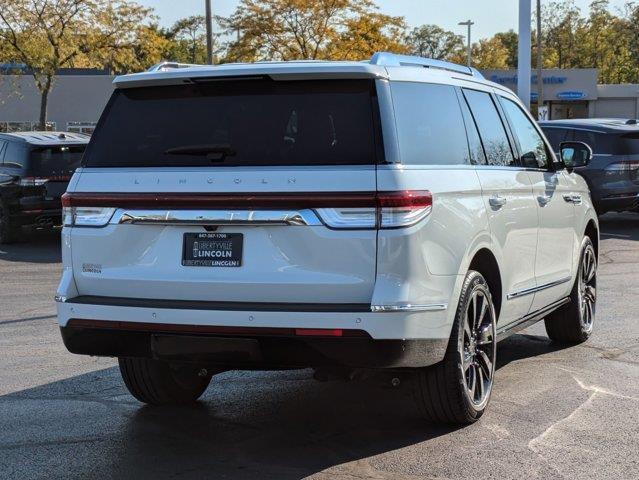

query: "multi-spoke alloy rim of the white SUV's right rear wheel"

left=462, top=289, right=496, bottom=409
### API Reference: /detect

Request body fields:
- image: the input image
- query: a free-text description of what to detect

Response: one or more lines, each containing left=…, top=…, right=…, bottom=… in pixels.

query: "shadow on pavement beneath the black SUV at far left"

left=0, top=229, right=62, bottom=263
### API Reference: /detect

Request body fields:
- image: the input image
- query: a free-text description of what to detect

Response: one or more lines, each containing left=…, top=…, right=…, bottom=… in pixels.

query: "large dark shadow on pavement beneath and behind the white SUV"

left=0, top=335, right=555, bottom=480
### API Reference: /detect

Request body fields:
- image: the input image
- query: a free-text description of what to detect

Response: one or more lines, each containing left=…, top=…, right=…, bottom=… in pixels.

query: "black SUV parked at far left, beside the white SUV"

left=0, top=132, right=89, bottom=243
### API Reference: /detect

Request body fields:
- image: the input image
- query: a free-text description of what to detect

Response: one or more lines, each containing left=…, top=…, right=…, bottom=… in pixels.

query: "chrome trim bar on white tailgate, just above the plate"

left=110, top=209, right=322, bottom=226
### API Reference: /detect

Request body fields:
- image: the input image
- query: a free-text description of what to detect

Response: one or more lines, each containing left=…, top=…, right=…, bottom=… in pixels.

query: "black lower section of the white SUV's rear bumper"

left=60, top=320, right=448, bottom=370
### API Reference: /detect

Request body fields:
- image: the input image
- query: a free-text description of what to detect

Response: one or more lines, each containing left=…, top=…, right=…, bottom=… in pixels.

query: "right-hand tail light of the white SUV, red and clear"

left=315, top=190, right=433, bottom=229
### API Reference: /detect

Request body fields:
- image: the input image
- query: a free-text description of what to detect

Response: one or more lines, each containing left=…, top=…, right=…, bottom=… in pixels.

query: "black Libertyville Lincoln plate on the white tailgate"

left=182, top=232, right=244, bottom=267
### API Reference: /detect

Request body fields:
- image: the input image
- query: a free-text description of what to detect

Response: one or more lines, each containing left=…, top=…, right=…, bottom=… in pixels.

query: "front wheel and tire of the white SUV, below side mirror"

left=544, top=237, right=597, bottom=345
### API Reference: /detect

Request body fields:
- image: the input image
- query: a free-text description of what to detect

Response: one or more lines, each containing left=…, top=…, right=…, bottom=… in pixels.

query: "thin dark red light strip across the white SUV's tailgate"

left=62, top=190, right=432, bottom=209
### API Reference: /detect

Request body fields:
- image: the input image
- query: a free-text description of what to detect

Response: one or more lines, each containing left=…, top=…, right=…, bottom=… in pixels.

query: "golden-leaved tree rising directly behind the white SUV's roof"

left=223, top=0, right=406, bottom=61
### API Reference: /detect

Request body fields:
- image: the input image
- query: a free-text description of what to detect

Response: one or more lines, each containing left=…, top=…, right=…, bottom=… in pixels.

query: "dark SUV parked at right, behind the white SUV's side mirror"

left=539, top=118, right=639, bottom=215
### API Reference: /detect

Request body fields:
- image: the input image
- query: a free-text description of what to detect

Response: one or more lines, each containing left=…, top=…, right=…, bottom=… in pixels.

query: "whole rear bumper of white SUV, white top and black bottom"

left=57, top=297, right=450, bottom=369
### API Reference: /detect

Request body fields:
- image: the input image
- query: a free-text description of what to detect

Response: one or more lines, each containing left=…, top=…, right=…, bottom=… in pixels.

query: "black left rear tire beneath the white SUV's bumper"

left=118, top=358, right=211, bottom=405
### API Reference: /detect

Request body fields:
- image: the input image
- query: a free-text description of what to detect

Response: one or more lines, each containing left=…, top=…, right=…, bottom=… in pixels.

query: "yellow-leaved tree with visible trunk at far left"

left=0, top=0, right=150, bottom=128
